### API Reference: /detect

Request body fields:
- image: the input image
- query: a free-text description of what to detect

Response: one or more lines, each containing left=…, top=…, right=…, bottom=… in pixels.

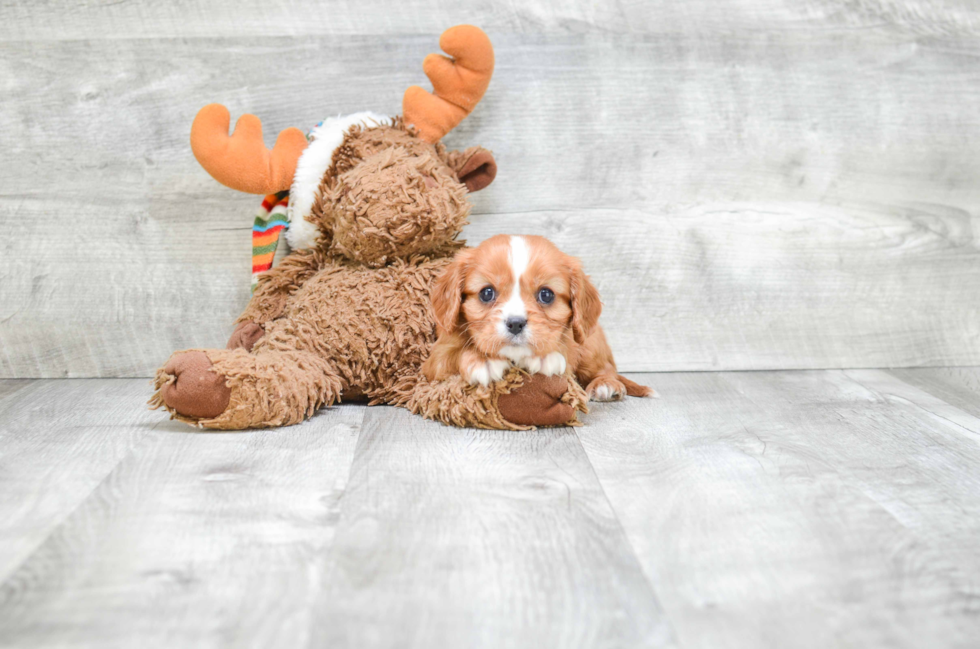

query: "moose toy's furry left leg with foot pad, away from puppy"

left=150, top=349, right=341, bottom=430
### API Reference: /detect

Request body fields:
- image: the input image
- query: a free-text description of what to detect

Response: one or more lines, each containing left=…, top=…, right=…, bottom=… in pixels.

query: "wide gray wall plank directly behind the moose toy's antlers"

left=7, top=30, right=980, bottom=218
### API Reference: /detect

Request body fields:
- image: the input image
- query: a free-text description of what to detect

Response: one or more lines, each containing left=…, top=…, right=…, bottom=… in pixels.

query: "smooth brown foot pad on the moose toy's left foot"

left=160, top=351, right=231, bottom=419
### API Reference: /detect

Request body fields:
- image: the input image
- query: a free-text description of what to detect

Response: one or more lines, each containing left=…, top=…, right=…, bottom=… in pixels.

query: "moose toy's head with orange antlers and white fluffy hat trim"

left=191, top=25, right=497, bottom=266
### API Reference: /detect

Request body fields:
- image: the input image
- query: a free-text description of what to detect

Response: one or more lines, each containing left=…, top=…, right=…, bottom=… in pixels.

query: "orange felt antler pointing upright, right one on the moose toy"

left=402, top=25, right=493, bottom=142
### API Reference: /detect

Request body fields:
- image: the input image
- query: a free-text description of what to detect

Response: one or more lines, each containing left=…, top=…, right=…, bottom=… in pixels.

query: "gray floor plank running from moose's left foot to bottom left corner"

left=0, top=398, right=365, bottom=647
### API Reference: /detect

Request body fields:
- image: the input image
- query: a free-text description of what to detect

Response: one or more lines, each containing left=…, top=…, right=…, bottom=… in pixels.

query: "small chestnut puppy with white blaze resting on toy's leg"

left=422, top=235, right=656, bottom=401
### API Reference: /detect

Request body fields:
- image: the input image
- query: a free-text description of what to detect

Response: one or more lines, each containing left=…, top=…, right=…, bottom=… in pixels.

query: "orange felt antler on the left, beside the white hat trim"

left=191, top=104, right=307, bottom=194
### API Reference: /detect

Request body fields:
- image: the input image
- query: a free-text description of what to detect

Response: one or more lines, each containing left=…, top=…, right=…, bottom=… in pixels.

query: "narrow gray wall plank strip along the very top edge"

left=7, top=0, right=980, bottom=40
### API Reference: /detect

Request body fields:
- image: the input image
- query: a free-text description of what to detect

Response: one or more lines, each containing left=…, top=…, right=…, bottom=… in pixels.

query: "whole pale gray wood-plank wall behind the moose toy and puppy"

left=0, top=0, right=980, bottom=377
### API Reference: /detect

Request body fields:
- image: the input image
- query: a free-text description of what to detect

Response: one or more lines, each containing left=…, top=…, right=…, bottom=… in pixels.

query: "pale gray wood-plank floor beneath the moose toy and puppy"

left=0, top=369, right=980, bottom=649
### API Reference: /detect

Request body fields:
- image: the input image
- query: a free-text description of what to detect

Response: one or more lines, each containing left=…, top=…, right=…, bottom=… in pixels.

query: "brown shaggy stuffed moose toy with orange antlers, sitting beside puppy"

left=150, top=25, right=587, bottom=429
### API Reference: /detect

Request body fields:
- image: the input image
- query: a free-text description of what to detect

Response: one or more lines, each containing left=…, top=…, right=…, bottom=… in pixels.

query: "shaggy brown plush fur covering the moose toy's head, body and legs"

left=150, top=120, right=587, bottom=429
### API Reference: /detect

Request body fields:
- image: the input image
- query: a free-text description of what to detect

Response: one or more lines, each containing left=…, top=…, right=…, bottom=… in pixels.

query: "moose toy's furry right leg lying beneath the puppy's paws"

left=392, top=369, right=588, bottom=430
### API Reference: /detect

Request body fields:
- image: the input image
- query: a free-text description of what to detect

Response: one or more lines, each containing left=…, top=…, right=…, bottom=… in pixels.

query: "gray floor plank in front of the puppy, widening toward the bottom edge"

left=311, top=408, right=670, bottom=649
